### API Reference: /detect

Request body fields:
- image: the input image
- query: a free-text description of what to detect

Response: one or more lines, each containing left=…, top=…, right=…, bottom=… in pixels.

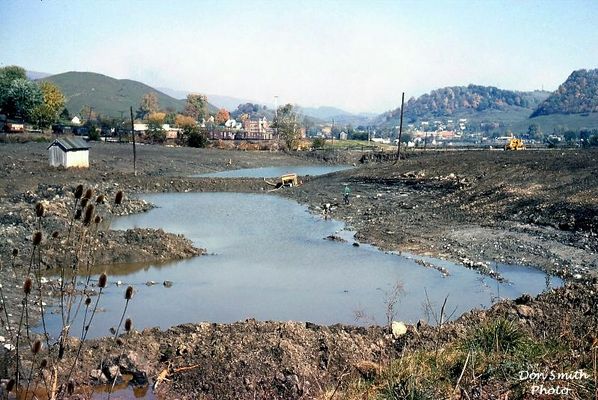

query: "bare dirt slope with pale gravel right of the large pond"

left=283, top=151, right=598, bottom=279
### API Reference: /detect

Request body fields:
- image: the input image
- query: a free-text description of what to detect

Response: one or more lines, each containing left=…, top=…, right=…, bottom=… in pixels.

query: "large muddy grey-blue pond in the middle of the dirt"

left=42, top=193, right=562, bottom=336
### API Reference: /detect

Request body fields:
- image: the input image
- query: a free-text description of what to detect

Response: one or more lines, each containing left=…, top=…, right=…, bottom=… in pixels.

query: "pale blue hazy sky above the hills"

left=0, top=0, right=598, bottom=112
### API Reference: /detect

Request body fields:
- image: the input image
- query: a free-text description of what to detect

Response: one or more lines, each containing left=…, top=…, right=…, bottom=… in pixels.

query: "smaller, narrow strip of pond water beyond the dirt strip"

left=193, top=165, right=353, bottom=178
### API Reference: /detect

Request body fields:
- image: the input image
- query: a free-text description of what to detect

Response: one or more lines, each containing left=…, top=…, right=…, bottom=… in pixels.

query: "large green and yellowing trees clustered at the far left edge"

left=0, top=65, right=65, bottom=128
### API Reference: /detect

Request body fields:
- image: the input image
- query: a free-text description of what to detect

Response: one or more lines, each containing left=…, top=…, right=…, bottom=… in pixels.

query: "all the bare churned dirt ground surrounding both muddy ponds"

left=0, top=143, right=598, bottom=399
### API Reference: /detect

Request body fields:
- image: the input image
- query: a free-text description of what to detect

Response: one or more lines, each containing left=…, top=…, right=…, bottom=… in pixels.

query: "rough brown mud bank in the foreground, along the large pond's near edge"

left=2, top=284, right=598, bottom=399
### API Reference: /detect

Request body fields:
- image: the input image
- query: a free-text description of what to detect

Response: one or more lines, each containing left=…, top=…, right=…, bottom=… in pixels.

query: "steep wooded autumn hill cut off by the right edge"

left=531, top=69, right=598, bottom=118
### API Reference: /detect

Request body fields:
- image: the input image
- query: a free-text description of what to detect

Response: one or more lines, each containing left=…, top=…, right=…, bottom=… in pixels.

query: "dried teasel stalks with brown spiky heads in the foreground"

left=0, top=185, right=133, bottom=400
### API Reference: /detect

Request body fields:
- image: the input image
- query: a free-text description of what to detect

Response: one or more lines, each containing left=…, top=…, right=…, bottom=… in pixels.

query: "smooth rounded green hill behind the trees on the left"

left=42, top=71, right=216, bottom=117
